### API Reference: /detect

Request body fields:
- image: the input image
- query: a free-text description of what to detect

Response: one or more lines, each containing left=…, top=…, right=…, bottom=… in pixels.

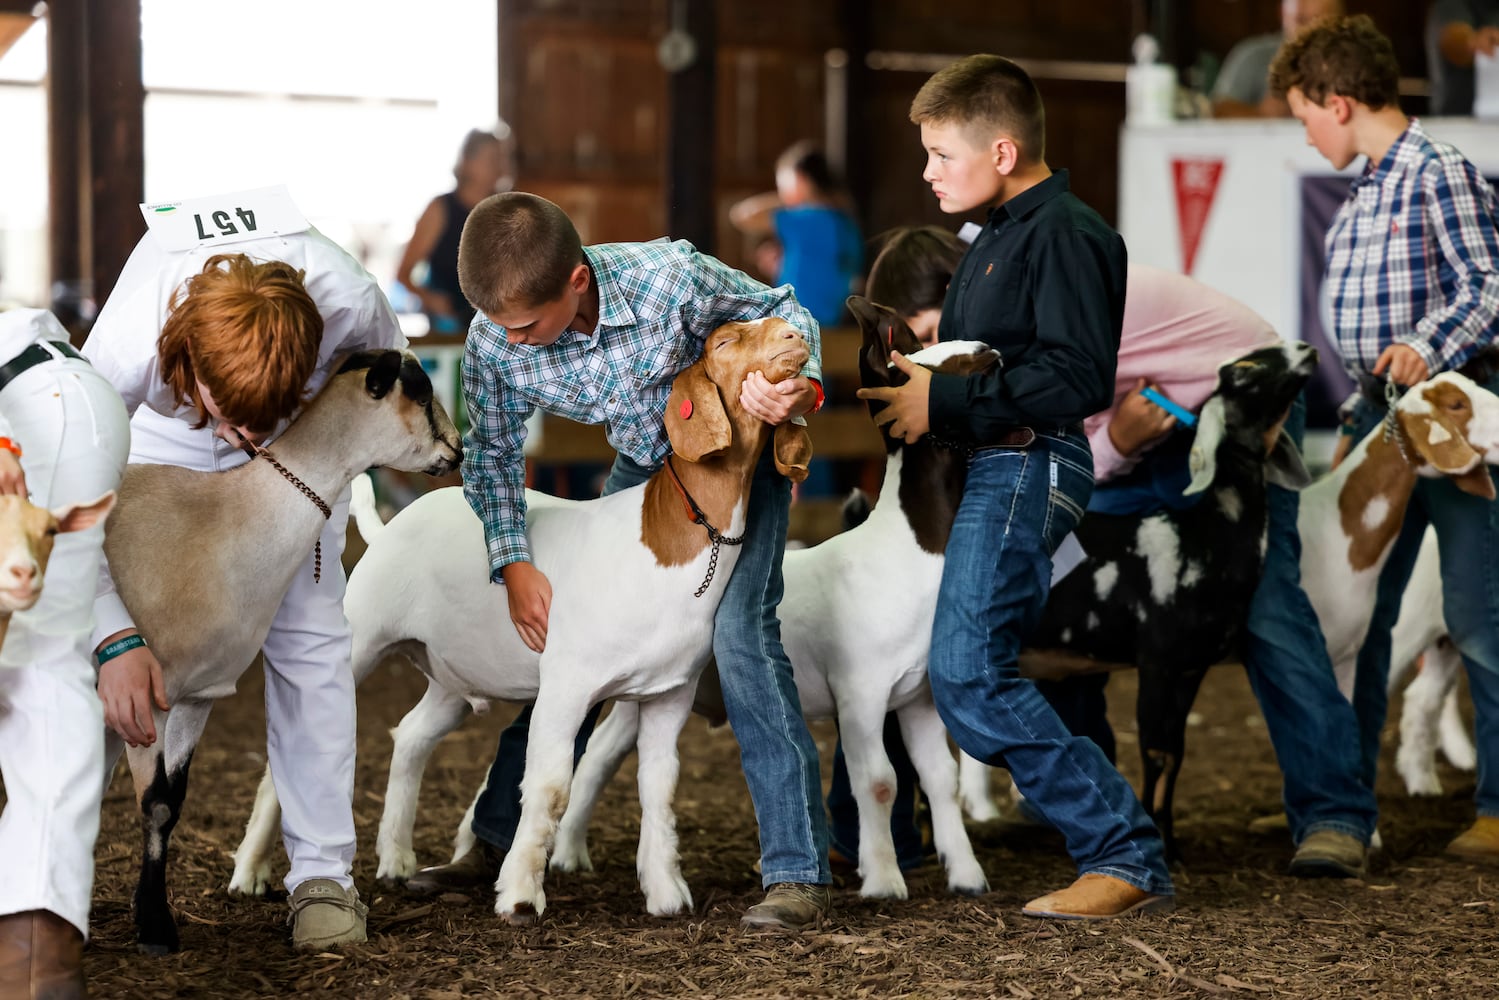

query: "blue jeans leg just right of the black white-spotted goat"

left=1244, top=399, right=1384, bottom=844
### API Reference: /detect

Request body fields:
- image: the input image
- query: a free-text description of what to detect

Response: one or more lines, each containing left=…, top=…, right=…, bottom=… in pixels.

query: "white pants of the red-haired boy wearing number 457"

left=130, top=408, right=355, bottom=892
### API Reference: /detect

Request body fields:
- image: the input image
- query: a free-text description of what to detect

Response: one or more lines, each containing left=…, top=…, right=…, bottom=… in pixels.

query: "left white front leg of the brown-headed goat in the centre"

left=495, top=689, right=595, bottom=925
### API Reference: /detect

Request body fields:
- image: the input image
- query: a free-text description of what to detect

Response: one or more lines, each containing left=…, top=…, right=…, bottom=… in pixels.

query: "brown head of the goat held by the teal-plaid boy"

left=666, top=316, right=812, bottom=483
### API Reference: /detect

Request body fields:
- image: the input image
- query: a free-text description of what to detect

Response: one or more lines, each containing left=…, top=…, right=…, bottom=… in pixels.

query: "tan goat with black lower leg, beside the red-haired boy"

left=105, top=351, right=463, bottom=954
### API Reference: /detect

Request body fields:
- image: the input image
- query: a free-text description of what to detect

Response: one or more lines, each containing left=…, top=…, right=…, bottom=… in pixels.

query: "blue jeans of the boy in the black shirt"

left=929, top=429, right=1172, bottom=894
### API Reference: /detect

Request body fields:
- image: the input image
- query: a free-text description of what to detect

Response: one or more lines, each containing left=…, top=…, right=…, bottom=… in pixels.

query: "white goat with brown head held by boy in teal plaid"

left=235, top=318, right=811, bottom=924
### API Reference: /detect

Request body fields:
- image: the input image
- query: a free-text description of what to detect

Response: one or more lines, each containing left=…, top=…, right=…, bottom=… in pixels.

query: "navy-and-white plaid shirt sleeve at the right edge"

left=1397, top=157, right=1499, bottom=373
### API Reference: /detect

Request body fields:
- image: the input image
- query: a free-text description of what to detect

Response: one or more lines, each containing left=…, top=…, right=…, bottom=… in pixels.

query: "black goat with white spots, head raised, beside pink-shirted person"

left=1021, top=342, right=1316, bottom=856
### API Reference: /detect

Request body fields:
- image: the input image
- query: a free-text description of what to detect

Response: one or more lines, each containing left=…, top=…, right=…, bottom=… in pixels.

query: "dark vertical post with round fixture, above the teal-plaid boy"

left=666, top=0, right=718, bottom=253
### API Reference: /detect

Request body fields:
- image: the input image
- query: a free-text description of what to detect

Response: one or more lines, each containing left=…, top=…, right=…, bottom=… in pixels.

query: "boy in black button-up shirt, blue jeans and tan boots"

left=859, top=55, right=1172, bottom=919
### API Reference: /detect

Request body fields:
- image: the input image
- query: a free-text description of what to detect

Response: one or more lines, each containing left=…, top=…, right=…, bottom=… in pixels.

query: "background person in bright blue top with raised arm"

left=729, top=141, right=863, bottom=327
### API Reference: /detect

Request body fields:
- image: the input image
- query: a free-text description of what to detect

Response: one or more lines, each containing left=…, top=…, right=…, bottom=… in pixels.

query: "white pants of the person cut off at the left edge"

left=0, top=357, right=130, bottom=937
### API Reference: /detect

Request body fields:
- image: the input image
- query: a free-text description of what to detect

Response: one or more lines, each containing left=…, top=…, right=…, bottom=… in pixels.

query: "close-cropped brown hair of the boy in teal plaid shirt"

left=459, top=190, right=583, bottom=316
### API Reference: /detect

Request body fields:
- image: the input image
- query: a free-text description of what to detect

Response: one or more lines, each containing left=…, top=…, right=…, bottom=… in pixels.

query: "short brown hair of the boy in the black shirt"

left=911, top=55, right=1046, bottom=162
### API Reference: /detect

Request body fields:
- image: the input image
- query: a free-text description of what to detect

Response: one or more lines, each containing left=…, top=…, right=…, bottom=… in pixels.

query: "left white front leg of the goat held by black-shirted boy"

left=833, top=704, right=907, bottom=900
